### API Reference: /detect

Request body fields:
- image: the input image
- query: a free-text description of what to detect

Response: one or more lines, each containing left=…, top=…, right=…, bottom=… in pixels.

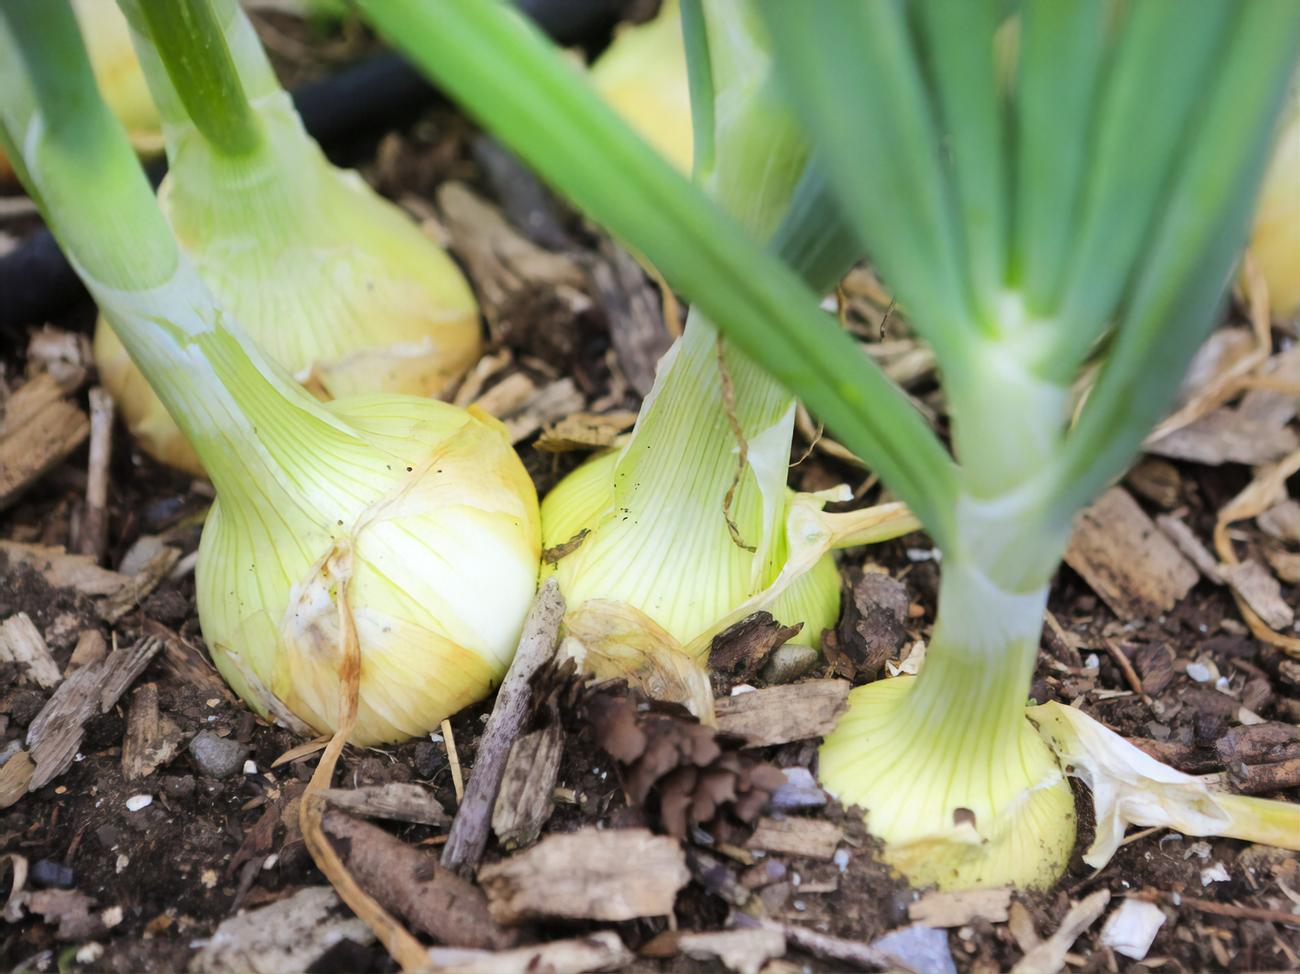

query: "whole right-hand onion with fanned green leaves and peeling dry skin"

left=359, top=0, right=1300, bottom=887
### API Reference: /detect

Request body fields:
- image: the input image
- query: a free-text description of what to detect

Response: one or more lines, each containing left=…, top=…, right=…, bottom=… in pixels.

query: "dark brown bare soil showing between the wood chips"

left=0, top=9, right=1300, bottom=971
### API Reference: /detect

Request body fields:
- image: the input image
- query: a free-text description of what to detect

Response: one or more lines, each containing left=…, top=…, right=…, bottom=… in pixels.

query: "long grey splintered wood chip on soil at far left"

left=27, top=638, right=163, bottom=791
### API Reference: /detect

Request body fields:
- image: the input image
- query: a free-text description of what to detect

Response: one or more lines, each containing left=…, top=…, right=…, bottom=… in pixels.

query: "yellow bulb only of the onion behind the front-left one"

left=95, top=124, right=481, bottom=476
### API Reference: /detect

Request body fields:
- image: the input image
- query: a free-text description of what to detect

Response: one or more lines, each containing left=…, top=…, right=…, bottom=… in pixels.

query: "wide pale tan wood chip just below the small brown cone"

left=478, top=828, right=690, bottom=923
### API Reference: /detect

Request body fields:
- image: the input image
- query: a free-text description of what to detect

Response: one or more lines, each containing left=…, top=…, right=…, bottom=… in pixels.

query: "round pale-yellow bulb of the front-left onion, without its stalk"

left=196, top=395, right=540, bottom=745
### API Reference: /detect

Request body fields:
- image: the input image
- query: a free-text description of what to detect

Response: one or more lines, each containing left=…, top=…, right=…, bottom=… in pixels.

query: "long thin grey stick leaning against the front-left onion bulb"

left=442, top=577, right=564, bottom=874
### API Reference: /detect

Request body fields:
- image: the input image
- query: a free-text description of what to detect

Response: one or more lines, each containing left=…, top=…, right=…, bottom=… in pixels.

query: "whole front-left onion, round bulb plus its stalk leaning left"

left=0, top=0, right=540, bottom=744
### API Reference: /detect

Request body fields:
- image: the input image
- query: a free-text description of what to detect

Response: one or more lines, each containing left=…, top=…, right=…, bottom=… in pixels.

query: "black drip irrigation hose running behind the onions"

left=0, top=0, right=628, bottom=330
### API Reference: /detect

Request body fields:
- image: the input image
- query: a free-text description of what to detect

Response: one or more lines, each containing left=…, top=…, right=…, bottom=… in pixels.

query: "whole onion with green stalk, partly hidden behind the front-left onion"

left=95, top=0, right=481, bottom=475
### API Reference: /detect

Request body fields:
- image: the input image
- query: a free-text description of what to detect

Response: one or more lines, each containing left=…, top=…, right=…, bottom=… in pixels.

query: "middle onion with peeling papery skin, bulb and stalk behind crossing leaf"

left=542, top=0, right=915, bottom=717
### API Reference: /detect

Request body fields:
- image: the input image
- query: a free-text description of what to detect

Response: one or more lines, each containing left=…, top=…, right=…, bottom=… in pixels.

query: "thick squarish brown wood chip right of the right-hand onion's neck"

left=1065, top=488, right=1200, bottom=620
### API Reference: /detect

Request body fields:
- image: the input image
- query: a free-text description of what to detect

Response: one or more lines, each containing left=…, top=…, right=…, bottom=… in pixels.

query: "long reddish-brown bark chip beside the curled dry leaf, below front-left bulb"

left=324, top=809, right=519, bottom=949
